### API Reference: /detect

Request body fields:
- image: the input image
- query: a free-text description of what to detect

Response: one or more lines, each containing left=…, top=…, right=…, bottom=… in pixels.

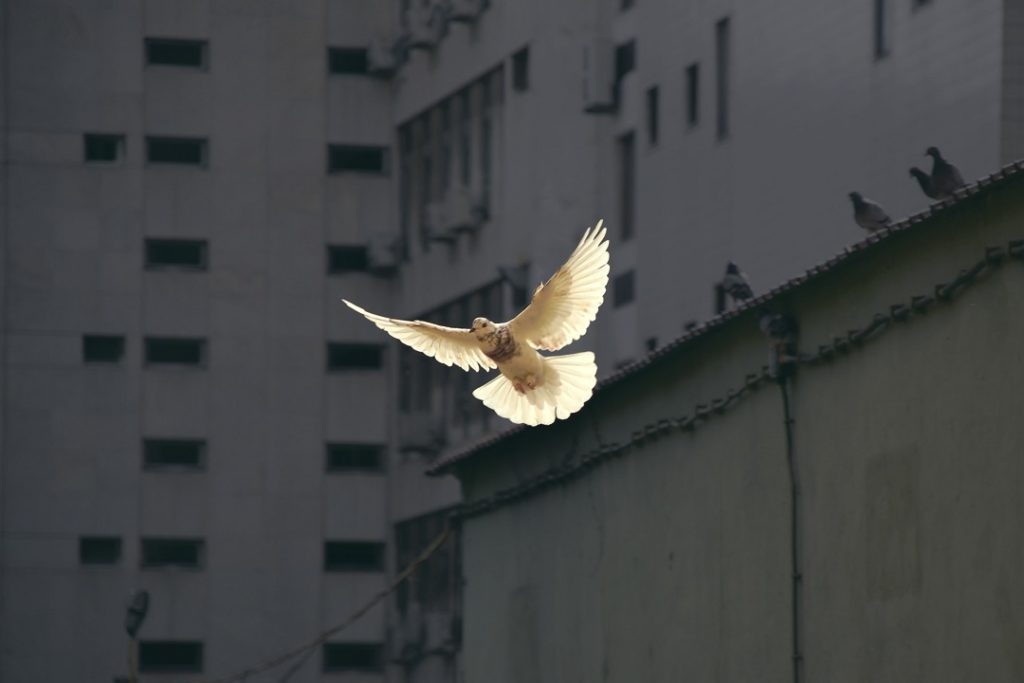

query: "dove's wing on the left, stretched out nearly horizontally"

left=342, top=299, right=498, bottom=371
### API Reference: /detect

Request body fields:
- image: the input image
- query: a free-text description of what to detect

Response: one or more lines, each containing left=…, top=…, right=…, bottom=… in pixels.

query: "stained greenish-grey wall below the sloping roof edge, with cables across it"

left=457, top=174, right=1024, bottom=683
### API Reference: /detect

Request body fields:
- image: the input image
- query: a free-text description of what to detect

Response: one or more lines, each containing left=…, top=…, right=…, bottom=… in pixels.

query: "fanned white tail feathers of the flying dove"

left=473, top=351, right=597, bottom=426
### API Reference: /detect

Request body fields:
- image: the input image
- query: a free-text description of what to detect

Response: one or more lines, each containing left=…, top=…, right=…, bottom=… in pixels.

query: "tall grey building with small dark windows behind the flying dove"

left=0, top=0, right=1024, bottom=683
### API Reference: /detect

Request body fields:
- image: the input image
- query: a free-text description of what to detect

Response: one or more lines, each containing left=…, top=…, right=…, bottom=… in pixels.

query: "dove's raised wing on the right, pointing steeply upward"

left=509, top=221, right=608, bottom=351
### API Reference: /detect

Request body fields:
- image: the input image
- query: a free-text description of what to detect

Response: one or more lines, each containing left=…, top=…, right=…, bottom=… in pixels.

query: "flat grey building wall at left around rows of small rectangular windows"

left=0, top=0, right=391, bottom=683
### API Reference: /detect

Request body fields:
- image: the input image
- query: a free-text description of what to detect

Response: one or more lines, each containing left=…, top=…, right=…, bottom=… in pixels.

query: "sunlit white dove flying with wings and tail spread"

left=342, top=221, right=608, bottom=426
